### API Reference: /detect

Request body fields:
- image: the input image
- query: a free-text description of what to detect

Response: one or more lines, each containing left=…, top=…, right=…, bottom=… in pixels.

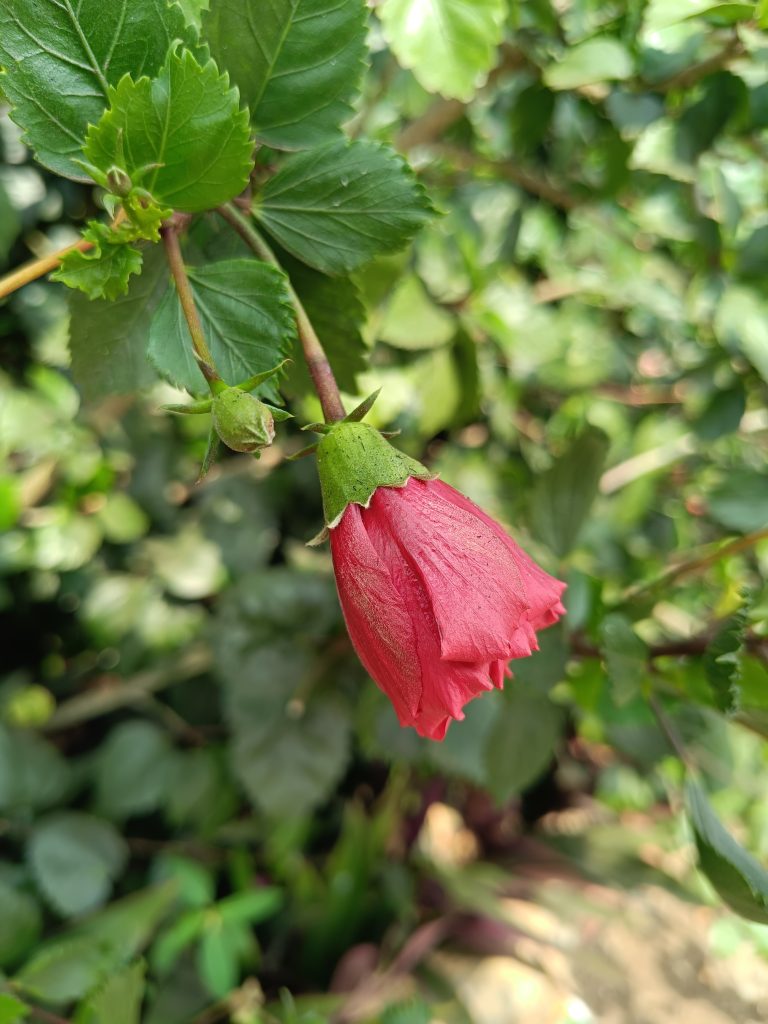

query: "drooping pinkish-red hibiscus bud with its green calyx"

left=317, top=423, right=565, bottom=739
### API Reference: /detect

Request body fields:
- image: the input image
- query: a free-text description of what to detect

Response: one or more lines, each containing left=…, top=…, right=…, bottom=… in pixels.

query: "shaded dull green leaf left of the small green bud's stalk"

left=70, top=246, right=168, bottom=400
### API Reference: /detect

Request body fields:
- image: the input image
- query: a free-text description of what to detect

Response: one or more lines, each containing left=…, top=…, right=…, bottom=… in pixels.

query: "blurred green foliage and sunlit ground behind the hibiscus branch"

left=0, top=0, right=768, bottom=1024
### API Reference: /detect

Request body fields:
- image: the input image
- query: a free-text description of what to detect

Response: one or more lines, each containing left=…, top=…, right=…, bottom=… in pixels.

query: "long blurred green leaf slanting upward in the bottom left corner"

left=14, top=884, right=176, bottom=1006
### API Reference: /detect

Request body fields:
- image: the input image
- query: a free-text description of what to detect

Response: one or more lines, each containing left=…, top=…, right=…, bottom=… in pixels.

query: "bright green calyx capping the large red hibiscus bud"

left=317, top=420, right=434, bottom=528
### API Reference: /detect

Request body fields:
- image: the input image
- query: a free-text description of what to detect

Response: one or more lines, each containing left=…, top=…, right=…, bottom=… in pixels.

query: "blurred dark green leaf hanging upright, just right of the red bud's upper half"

left=530, top=427, right=608, bottom=556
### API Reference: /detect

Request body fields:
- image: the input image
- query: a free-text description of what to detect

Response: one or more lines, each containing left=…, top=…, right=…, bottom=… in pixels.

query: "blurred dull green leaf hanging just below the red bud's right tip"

left=485, top=679, right=563, bottom=804
